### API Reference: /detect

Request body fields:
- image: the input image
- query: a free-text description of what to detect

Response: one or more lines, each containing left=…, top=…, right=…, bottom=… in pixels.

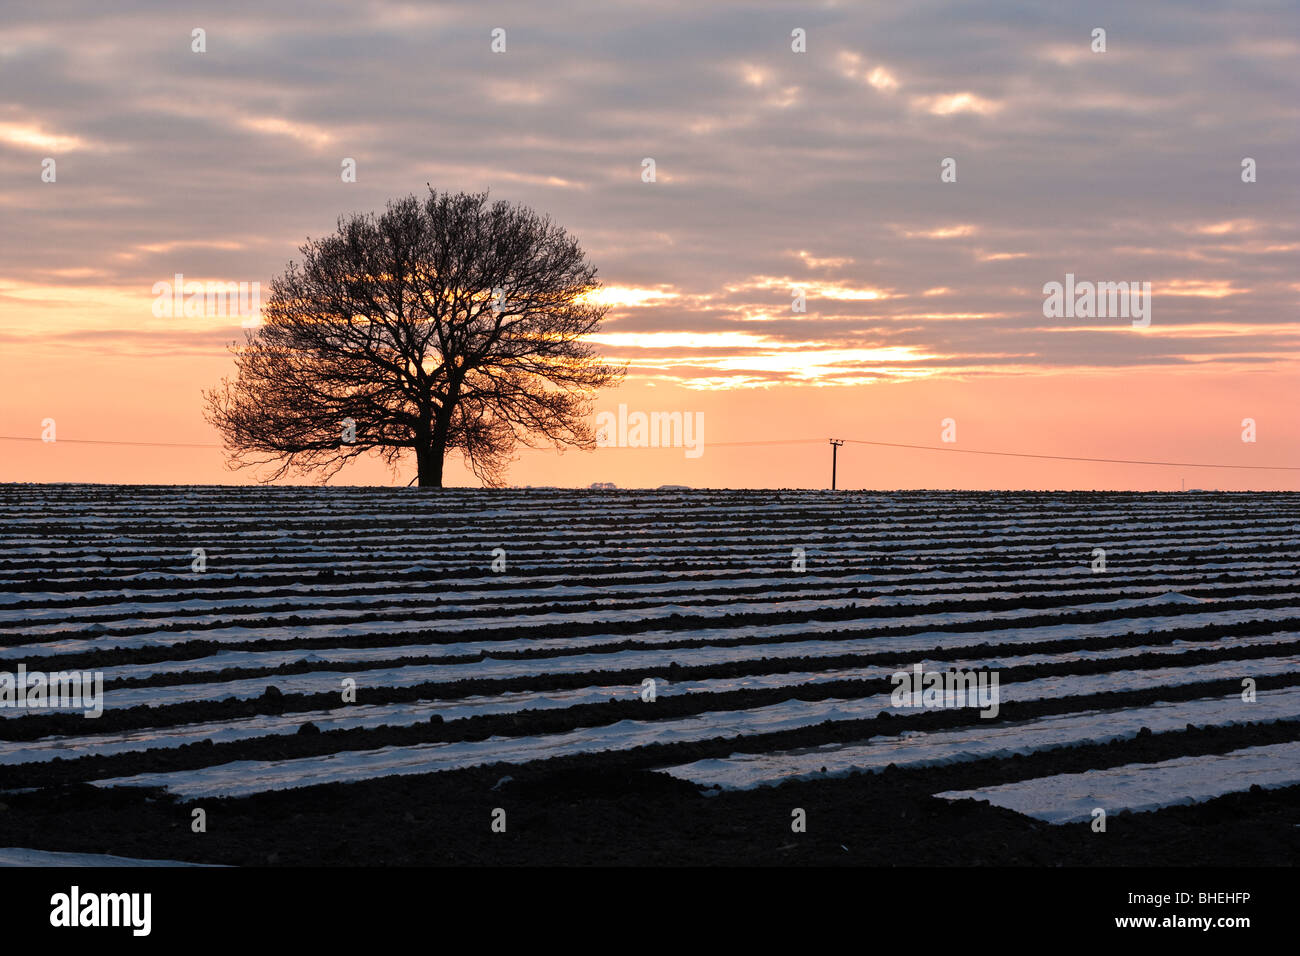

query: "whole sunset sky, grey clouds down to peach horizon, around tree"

left=0, top=0, right=1300, bottom=490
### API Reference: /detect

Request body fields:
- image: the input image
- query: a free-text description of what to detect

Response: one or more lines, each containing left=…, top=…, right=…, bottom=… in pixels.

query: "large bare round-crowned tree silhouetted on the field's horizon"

left=205, top=187, right=624, bottom=488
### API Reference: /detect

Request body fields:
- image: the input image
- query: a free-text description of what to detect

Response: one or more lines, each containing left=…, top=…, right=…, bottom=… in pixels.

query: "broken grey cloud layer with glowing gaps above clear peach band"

left=0, top=0, right=1300, bottom=388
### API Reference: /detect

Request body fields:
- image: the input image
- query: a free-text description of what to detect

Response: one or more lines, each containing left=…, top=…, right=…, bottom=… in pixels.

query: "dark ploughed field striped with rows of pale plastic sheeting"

left=0, top=485, right=1300, bottom=865
